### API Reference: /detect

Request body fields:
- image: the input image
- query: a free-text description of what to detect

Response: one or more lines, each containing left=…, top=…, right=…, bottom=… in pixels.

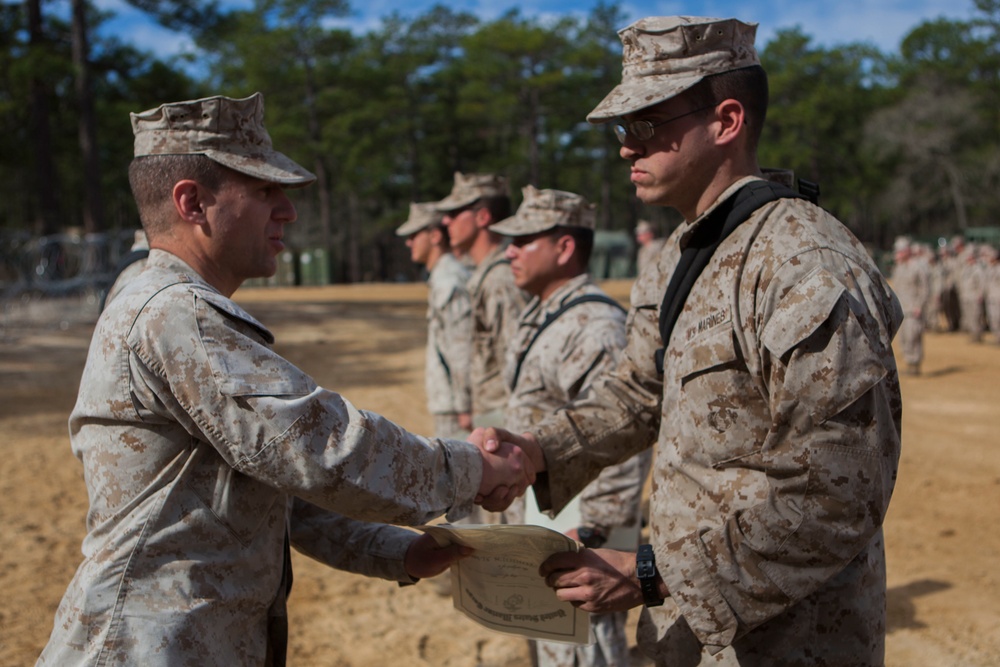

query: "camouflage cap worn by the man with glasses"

left=587, top=16, right=760, bottom=124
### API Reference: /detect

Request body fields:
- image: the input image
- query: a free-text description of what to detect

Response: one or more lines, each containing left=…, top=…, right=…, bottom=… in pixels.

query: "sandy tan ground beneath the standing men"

left=0, top=282, right=1000, bottom=667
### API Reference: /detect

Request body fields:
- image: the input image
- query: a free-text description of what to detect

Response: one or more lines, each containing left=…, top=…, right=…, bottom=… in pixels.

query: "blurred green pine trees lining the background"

left=0, top=0, right=1000, bottom=279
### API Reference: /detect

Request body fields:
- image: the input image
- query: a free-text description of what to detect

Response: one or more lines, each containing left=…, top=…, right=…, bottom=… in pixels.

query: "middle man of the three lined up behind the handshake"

left=437, top=172, right=527, bottom=524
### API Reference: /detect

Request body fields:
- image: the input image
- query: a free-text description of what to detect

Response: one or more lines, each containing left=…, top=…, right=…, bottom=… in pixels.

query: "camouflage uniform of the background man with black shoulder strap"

left=504, top=273, right=652, bottom=667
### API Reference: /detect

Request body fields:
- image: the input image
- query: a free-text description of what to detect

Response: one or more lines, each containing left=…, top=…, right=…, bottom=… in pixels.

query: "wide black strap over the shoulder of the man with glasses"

left=656, top=181, right=819, bottom=375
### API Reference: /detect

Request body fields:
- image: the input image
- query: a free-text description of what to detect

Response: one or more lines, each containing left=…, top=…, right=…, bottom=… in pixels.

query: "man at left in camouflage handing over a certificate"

left=38, top=94, right=532, bottom=667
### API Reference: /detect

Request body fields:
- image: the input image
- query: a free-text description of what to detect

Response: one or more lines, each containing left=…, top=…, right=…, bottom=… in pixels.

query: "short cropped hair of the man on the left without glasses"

left=128, top=155, right=230, bottom=239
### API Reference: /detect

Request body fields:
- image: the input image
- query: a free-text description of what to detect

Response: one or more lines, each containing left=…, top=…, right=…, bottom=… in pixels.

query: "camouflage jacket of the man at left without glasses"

left=39, top=250, right=482, bottom=667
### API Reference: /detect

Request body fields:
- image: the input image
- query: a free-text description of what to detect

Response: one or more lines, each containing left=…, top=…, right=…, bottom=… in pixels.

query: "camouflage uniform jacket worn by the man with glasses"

left=535, top=178, right=902, bottom=666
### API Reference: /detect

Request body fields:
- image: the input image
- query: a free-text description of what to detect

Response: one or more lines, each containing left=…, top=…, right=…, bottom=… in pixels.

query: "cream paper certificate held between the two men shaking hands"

left=420, top=524, right=593, bottom=644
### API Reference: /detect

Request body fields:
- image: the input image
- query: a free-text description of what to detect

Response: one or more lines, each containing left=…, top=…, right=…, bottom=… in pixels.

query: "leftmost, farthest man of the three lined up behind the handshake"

left=396, top=202, right=472, bottom=438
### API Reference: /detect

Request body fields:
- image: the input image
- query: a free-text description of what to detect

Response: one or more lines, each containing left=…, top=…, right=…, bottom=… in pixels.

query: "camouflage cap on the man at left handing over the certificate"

left=129, top=93, right=316, bottom=187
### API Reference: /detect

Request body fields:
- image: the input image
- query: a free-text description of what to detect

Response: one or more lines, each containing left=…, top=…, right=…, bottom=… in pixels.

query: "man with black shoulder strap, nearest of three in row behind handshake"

left=494, top=186, right=651, bottom=667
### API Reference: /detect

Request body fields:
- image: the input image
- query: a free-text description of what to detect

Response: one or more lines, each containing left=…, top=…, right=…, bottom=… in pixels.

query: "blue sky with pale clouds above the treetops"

left=90, top=0, right=973, bottom=63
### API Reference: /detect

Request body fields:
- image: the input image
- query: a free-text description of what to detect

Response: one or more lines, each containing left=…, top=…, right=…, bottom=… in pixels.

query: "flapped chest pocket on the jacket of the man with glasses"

left=673, top=321, right=768, bottom=467
